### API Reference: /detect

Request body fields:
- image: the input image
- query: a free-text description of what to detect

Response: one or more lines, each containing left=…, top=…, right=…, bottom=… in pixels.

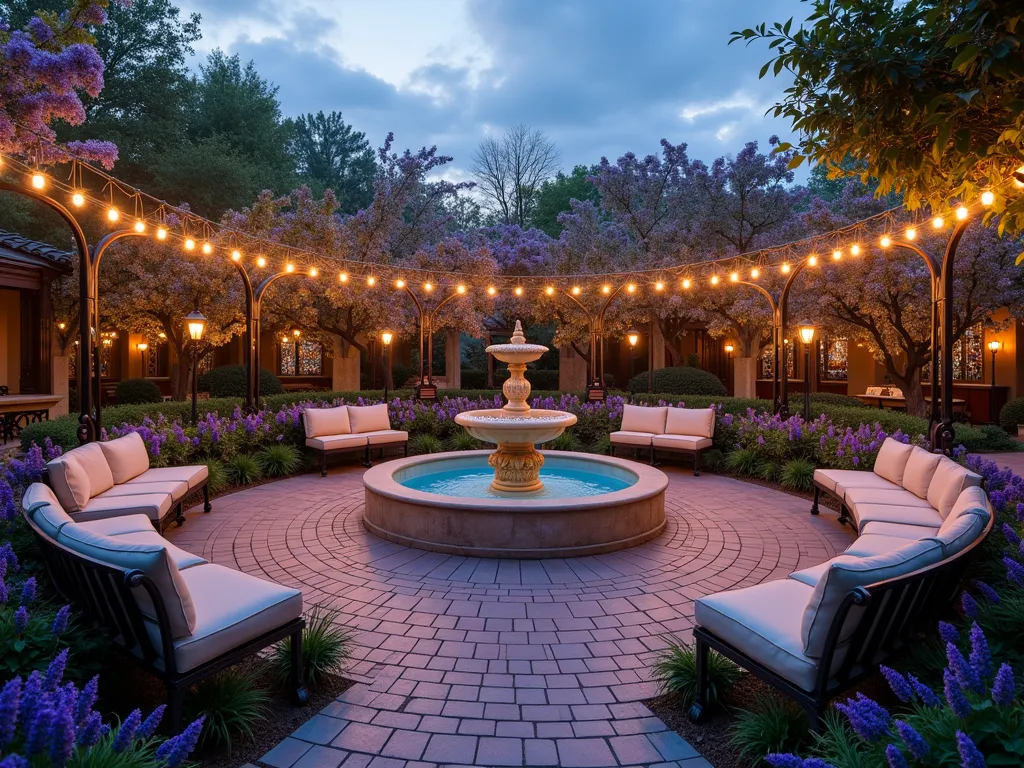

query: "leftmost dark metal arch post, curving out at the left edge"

left=0, top=181, right=99, bottom=444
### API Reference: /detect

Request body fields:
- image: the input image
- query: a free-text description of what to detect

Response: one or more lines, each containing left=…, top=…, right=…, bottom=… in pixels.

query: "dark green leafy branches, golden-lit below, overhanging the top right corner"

left=733, top=0, right=1024, bottom=231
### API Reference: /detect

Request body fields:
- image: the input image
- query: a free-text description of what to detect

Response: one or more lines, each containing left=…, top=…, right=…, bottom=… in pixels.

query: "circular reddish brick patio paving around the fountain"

left=167, top=468, right=852, bottom=768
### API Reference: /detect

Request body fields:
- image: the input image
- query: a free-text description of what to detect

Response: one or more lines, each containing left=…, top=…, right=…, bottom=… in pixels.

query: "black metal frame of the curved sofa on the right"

left=689, top=515, right=994, bottom=731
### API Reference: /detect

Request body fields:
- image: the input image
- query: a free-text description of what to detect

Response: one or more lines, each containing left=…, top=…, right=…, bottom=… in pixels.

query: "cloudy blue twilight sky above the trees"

left=179, top=0, right=808, bottom=185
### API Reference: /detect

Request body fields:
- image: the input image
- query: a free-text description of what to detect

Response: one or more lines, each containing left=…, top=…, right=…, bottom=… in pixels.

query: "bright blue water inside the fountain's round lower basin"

left=395, top=456, right=637, bottom=499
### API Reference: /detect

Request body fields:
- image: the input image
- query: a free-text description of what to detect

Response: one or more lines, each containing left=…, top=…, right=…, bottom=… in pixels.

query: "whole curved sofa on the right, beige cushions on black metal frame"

left=690, top=438, right=993, bottom=728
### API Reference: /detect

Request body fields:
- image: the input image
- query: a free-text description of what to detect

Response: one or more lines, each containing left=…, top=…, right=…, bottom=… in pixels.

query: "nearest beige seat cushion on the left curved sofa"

left=151, top=563, right=302, bottom=672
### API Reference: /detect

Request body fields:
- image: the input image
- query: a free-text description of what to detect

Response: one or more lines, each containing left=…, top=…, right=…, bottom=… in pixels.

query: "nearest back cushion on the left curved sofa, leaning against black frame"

left=57, top=525, right=196, bottom=637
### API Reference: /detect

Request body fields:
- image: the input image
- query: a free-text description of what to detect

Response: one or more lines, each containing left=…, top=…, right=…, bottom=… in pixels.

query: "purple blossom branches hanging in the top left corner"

left=0, top=0, right=118, bottom=168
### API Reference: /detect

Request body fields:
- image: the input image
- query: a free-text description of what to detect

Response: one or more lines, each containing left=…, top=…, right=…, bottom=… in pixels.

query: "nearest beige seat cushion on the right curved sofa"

left=694, top=579, right=842, bottom=691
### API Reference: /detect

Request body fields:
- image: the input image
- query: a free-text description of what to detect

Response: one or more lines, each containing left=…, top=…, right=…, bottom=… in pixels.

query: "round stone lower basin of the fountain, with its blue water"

left=362, top=451, right=669, bottom=558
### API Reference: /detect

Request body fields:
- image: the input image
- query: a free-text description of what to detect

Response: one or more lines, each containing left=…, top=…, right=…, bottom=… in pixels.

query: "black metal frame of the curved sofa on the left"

left=24, top=515, right=309, bottom=733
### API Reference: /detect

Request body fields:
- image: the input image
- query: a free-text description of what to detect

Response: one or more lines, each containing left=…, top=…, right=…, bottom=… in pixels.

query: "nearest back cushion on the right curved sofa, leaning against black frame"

left=798, top=544, right=942, bottom=658
